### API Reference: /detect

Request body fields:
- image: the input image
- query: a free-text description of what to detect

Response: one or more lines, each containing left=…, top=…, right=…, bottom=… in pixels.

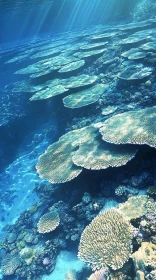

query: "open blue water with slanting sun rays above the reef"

left=0, top=0, right=136, bottom=43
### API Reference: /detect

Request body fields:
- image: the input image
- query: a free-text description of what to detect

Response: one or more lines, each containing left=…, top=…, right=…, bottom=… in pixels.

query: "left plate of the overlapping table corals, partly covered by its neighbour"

left=36, top=131, right=82, bottom=183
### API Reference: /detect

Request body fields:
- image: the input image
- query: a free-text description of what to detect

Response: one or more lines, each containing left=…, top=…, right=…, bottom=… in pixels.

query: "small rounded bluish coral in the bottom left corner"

left=1, top=254, right=21, bottom=275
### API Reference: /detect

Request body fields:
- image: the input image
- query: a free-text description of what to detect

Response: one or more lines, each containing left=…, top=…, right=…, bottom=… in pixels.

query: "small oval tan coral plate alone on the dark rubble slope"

left=37, top=209, right=60, bottom=233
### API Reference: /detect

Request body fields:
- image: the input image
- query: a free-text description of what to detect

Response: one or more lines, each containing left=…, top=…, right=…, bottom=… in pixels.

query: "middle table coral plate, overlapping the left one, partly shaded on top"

left=72, top=129, right=136, bottom=170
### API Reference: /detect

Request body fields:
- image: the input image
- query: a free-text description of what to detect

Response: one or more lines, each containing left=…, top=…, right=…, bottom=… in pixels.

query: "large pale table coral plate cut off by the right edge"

left=100, top=106, right=156, bottom=147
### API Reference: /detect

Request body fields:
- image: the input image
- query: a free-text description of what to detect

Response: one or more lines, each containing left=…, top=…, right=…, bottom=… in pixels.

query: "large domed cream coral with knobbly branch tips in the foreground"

left=78, top=209, right=132, bottom=270
